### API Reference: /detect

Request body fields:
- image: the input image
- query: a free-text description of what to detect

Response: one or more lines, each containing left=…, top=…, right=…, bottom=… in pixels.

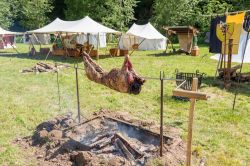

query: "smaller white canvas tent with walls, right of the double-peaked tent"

left=119, top=23, right=166, bottom=50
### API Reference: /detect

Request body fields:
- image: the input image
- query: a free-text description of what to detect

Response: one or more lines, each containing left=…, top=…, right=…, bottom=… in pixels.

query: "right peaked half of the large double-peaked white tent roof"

left=65, top=16, right=119, bottom=34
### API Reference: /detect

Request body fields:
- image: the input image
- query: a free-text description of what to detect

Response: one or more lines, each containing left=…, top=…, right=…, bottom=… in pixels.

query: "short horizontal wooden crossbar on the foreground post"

left=173, top=89, right=209, bottom=100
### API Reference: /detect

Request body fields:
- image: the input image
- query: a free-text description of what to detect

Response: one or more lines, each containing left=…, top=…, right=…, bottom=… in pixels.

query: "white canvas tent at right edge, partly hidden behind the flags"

left=211, top=30, right=250, bottom=63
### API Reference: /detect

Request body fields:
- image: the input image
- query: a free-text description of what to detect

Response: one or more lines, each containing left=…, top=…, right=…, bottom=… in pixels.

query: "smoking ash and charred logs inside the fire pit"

left=75, top=117, right=172, bottom=165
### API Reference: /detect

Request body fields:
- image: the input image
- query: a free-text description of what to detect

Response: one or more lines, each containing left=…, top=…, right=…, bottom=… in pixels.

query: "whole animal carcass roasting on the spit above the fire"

left=83, top=52, right=145, bottom=94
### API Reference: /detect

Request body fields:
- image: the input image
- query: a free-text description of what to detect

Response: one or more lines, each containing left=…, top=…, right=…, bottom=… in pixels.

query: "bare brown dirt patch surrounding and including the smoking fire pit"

left=15, top=110, right=185, bottom=166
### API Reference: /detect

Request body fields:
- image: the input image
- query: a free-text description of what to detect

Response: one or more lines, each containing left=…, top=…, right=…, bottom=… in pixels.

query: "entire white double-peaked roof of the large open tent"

left=28, top=16, right=118, bottom=34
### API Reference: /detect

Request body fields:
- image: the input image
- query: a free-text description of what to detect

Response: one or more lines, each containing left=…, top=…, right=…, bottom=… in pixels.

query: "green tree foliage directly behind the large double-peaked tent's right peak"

left=65, top=0, right=137, bottom=30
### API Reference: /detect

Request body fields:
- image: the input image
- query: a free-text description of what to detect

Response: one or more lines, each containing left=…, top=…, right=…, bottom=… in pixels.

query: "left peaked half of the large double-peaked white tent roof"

left=28, top=18, right=80, bottom=33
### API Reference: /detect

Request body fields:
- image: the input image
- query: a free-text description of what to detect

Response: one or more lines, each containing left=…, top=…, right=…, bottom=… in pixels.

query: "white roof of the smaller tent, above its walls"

left=126, top=23, right=166, bottom=39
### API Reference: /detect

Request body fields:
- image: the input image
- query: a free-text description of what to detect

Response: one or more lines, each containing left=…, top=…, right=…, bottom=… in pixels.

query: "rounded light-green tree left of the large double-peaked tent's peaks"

left=19, top=0, right=53, bottom=29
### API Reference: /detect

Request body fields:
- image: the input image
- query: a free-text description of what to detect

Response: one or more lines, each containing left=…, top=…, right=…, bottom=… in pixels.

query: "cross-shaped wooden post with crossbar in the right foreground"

left=173, top=78, right=209, bottom=166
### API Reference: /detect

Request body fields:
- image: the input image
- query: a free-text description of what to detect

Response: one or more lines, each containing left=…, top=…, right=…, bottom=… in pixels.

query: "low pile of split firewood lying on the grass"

left=22, top=62, right=69, bottom=73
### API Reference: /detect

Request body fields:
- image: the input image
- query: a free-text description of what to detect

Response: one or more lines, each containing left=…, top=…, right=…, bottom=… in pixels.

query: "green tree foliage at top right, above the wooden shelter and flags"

left=152, top=0, right=250, bottom=32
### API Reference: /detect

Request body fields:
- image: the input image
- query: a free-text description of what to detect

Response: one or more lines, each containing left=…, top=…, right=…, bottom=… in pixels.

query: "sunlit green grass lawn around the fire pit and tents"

left=0, top=44, right=250, bottom=166
